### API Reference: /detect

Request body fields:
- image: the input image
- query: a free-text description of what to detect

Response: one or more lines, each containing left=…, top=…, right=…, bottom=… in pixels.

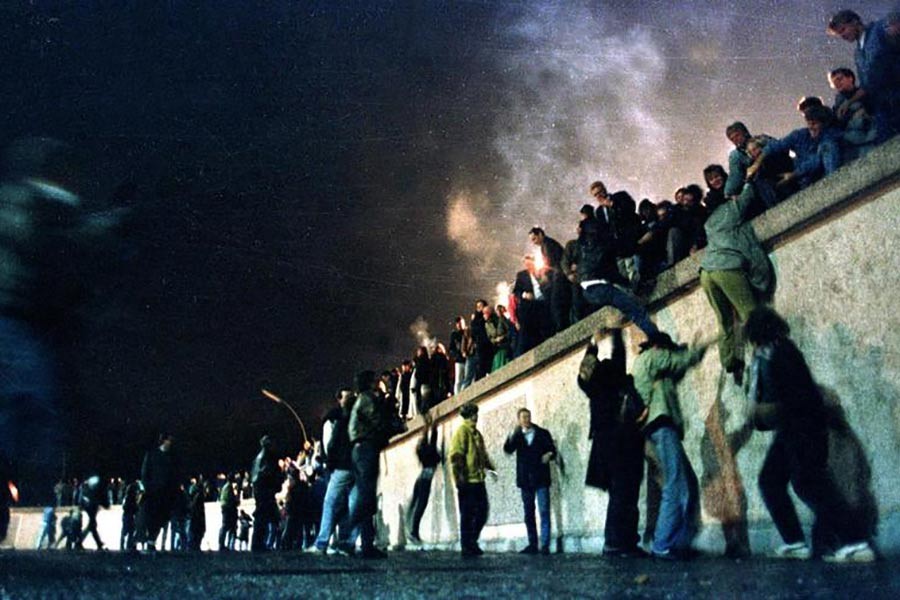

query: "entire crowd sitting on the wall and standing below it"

left=3, top=10, right=900, bottom=562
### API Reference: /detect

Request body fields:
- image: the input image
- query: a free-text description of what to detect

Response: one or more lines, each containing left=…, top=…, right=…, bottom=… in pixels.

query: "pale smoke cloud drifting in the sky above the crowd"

left=447, top=0, right=671, bottom=281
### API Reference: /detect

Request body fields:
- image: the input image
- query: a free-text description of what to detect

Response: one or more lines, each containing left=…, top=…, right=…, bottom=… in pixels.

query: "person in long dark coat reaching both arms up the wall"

left=578, top=329, right=647, bottom=558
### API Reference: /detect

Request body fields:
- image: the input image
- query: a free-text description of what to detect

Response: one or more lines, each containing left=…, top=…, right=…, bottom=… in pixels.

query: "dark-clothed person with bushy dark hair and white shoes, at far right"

left=744, top=307, right=878, bottom=562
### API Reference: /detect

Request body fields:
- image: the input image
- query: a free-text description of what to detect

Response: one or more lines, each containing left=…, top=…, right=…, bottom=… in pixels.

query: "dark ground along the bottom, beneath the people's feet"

left=0, top=551, right=900, bottom=600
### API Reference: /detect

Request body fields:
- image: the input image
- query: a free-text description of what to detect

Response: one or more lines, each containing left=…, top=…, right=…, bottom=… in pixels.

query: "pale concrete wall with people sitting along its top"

left=381, top=139, right=900, bottom=552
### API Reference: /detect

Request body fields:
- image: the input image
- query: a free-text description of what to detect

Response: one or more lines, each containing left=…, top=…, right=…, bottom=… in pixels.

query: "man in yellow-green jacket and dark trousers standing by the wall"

left=449, top=402, right=494, bottom=558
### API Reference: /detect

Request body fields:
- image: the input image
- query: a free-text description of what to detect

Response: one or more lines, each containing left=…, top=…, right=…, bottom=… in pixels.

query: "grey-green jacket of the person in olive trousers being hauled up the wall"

left=700, top=185, right=773, bottom=294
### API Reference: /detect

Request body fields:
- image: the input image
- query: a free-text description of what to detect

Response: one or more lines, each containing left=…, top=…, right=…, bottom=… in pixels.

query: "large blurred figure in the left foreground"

left=0, top=138, right=113, bottom=504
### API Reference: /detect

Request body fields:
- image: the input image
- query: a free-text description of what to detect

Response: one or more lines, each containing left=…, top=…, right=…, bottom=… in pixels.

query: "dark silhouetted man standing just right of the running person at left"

left=138, top=433, right=180, bottom=552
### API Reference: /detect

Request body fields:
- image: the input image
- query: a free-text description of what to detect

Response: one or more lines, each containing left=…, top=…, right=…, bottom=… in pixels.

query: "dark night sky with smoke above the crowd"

left=0, top=0, right=893, bottom=474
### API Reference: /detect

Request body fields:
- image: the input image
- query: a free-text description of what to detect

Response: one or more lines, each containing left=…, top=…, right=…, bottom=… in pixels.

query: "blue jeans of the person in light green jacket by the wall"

left=650, top=425, right=700, bottom=554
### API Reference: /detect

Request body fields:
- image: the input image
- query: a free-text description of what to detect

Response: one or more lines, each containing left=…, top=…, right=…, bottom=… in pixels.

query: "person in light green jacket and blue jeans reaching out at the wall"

left=634, top=333, right=707, bottom=560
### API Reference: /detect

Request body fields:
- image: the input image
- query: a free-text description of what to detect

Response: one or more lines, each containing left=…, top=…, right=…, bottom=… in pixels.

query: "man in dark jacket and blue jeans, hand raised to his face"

left=503, top=408, right=556, bottom=554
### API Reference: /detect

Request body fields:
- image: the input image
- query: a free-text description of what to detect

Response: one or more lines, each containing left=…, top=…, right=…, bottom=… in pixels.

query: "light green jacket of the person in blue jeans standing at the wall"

left=632, top=347, right=705, bottom=437
